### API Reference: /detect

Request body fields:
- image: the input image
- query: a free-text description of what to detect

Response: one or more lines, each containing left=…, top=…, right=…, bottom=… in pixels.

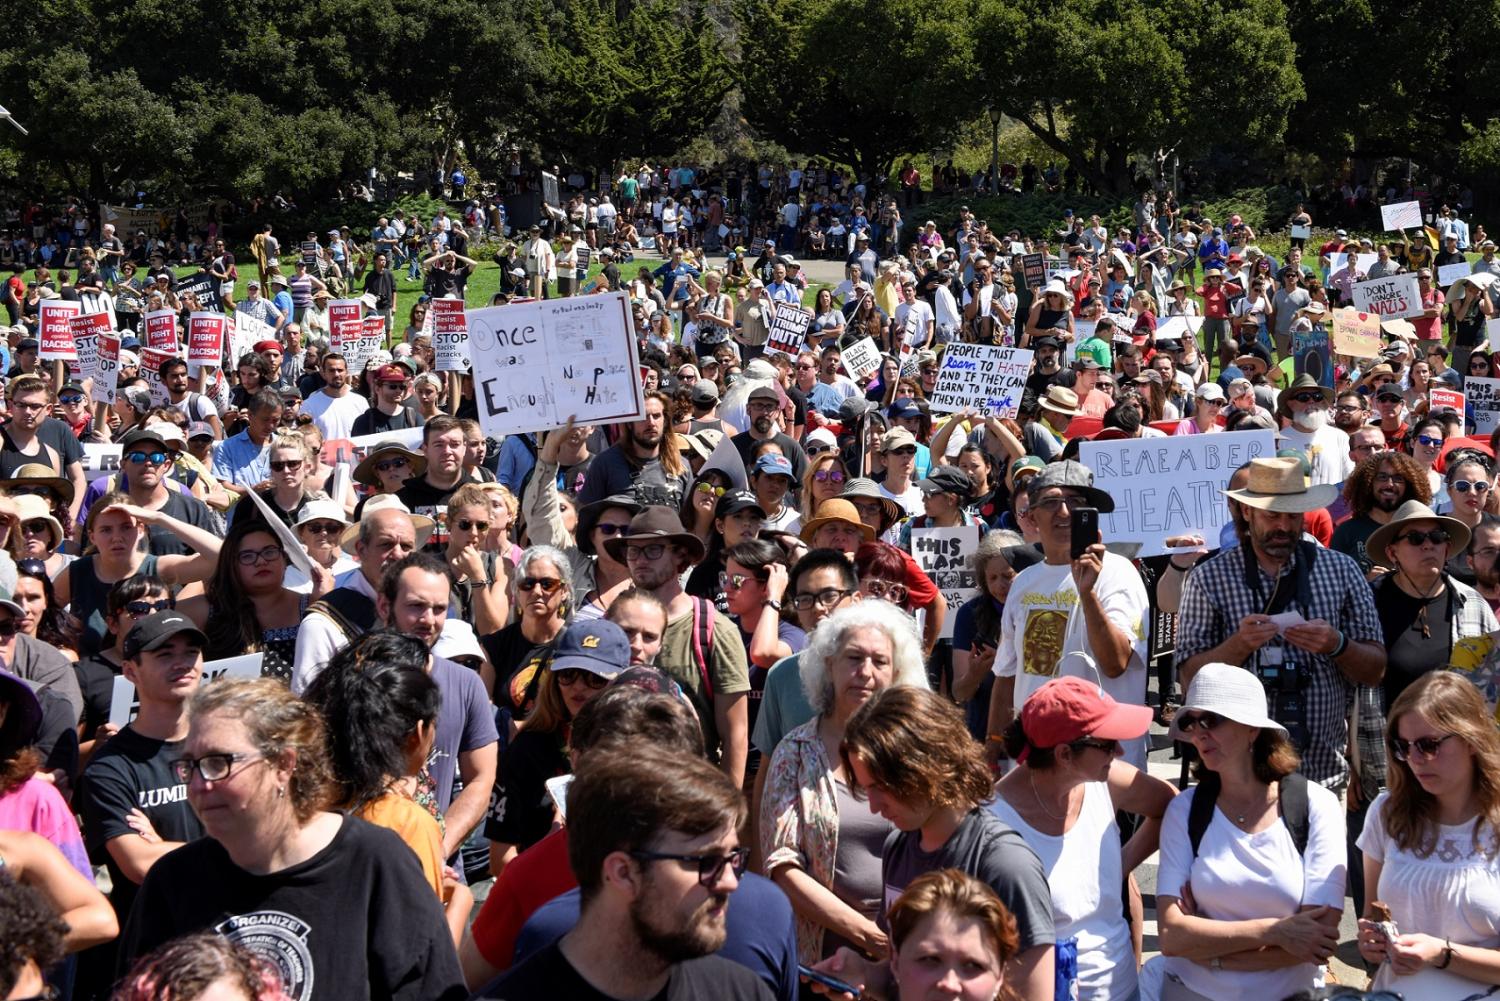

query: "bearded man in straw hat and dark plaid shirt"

left=1175, top=453, right=1386, bottom=792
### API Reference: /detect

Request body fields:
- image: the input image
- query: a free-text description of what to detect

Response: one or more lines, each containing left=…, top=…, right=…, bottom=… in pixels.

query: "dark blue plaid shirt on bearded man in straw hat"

left=1175, top=545, right=1385, bottom=789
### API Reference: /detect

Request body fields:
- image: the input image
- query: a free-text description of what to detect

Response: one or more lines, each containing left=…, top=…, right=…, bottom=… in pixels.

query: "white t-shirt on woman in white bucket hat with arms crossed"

left=1157, top=782, right=1350, bottom=1001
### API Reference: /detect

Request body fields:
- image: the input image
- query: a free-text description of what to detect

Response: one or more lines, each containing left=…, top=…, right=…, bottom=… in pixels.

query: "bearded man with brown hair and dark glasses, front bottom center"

left=485, top=744, right=774, bottom=1001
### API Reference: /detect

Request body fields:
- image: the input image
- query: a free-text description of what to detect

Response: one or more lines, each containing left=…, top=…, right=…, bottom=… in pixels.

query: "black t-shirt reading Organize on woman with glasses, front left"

left=120, top=816, right=468, bottom=1001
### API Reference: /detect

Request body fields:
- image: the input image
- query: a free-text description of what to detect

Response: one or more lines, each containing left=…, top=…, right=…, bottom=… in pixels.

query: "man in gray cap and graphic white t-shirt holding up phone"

left=986, top=459, right=1151, bottom=768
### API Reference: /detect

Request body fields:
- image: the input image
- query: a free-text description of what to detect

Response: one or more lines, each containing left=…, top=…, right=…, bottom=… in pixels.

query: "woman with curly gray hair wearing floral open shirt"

left=759, top=600, right=927, bottom=963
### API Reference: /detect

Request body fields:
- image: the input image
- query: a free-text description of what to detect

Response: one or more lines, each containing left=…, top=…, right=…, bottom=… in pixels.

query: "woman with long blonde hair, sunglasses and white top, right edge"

left=1358, top=671, right=1500, bottom=1001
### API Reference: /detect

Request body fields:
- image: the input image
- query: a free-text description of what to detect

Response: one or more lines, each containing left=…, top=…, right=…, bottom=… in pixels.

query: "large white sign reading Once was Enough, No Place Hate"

left=468, top=285, right=645, bottom=437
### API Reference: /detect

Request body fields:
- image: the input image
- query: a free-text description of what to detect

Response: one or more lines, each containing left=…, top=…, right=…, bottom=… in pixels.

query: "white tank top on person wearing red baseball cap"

left=990, top=782, right=1137, bottom=1001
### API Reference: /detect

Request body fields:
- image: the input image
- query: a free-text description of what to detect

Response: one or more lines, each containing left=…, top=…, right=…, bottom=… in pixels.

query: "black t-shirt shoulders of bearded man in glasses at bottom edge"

left=482, top=942, right=776, bottom=1001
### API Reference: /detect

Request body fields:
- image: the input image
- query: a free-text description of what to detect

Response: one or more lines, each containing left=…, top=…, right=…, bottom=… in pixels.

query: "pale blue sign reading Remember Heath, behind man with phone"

left=1079, top=431, right=1277, bottom=557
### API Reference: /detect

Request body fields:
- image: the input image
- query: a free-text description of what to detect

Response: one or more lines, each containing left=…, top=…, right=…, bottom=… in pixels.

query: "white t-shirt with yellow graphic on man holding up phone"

left=993, top=552, right=1151, bottom=768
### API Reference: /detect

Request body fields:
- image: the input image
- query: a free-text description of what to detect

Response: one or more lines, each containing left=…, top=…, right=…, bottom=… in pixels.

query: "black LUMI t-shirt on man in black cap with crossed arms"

left=74, top=726, right=203, bottom=921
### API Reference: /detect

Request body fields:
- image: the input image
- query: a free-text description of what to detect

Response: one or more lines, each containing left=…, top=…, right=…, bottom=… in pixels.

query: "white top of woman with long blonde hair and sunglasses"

left=1356, top=792, right=1500, bottom=998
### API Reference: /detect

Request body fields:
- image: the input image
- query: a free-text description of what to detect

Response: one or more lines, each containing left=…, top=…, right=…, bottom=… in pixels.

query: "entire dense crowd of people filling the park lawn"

left=0, top=171, right=1500, bottom=1001
